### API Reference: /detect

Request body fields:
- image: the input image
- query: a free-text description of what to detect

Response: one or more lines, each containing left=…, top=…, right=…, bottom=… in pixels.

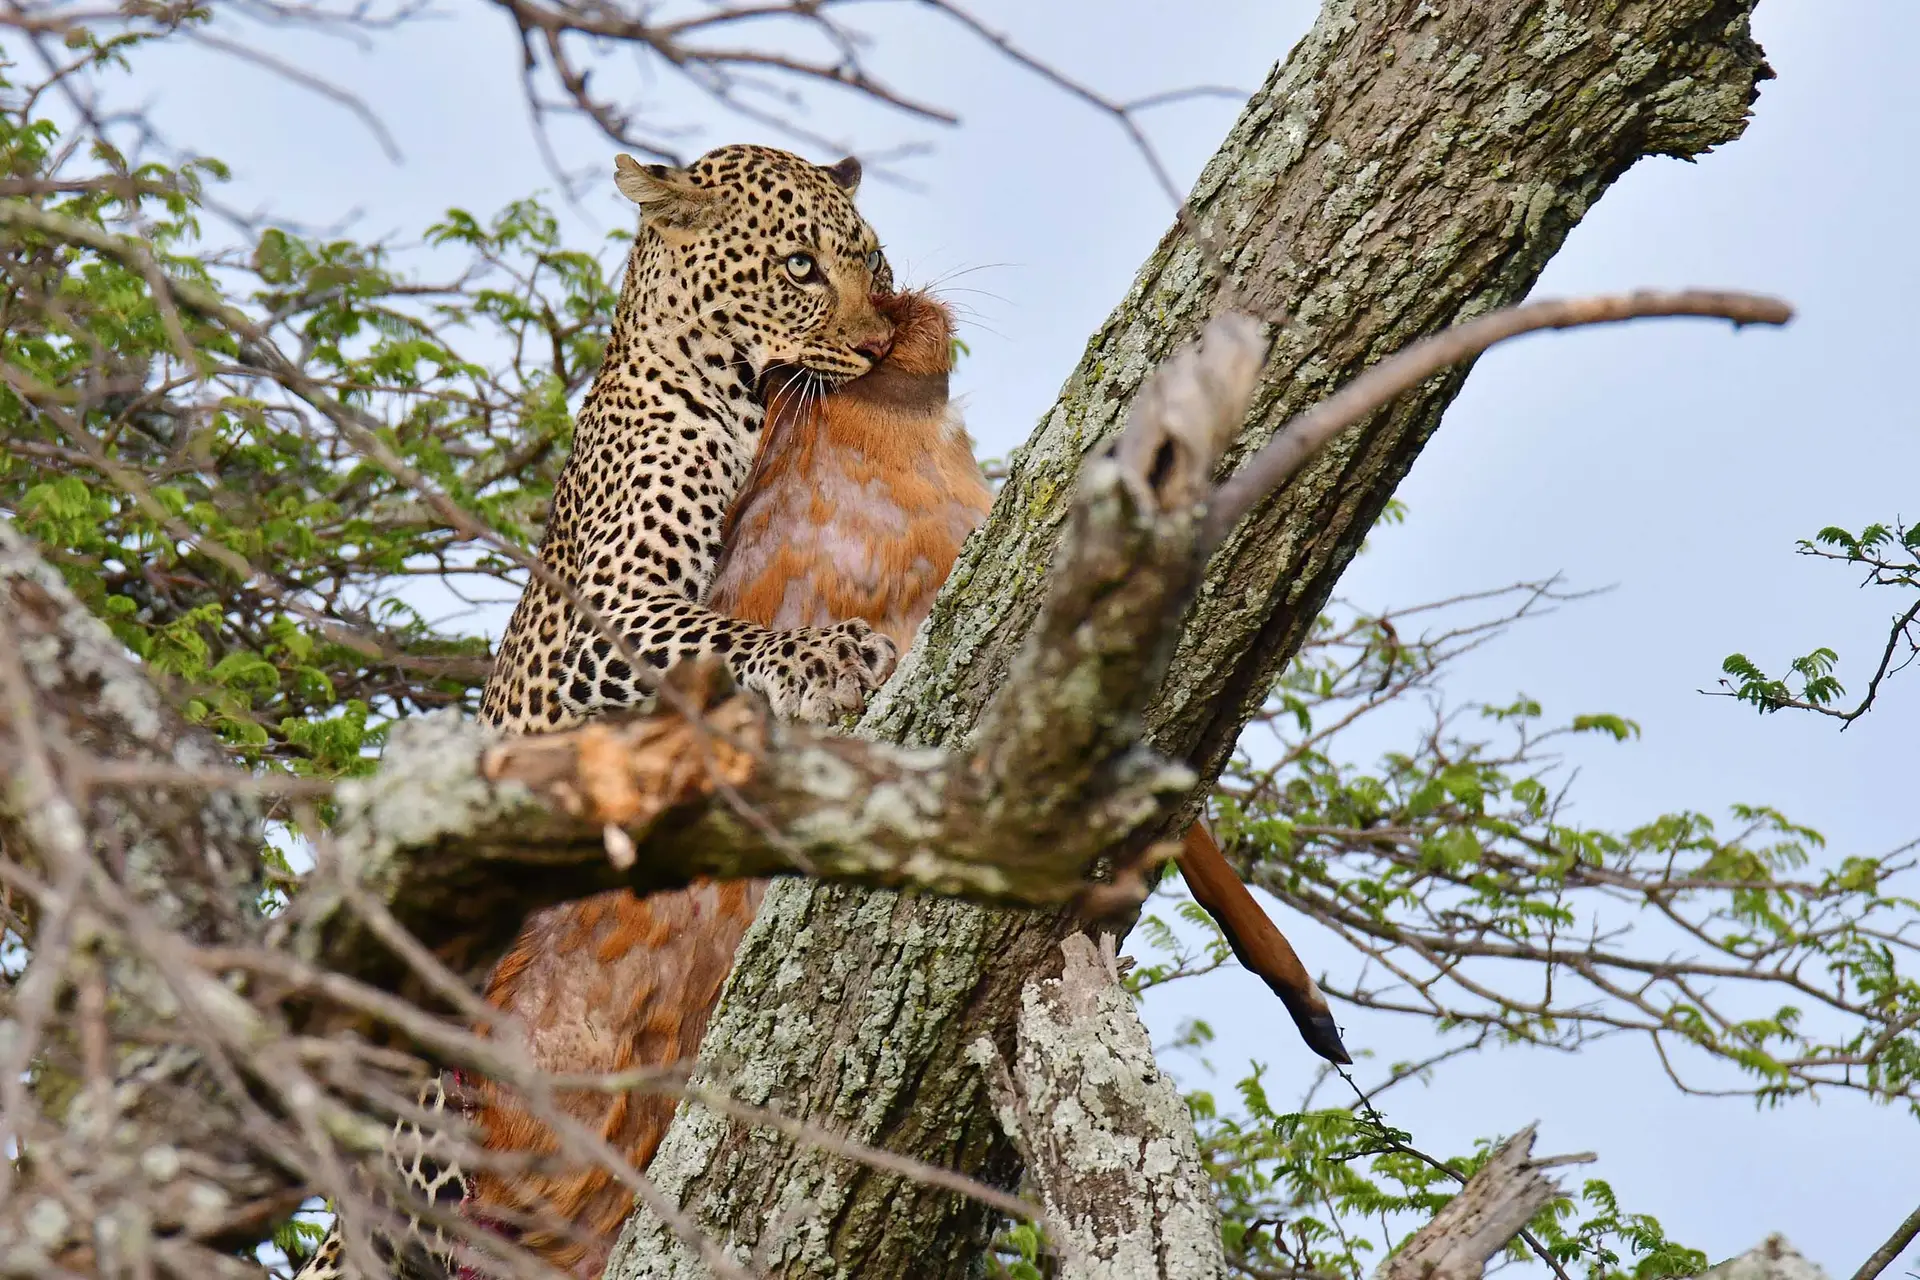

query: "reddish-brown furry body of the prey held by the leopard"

left=461, top=290, right=991, bottom=1280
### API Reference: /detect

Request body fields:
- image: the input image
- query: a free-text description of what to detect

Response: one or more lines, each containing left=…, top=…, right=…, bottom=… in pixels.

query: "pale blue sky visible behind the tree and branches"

left=127, top=0, right=1920, bottom=1276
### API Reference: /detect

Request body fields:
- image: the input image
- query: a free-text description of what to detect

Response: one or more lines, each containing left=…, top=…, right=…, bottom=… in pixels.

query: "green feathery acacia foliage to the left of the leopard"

left=0, top=44, right=614, bottom=777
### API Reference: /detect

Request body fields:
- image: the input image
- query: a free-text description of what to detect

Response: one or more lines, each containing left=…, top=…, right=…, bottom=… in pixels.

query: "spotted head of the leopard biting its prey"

left=614, top=146, right=893, bottom=382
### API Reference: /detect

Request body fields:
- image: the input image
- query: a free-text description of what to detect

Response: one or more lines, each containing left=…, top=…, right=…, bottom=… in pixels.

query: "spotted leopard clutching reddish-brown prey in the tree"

left=298, top=144, right=899, bottom=1280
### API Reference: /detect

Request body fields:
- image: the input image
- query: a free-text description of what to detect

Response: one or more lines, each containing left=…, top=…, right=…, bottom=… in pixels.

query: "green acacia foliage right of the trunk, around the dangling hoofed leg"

left=1131, top=575, right=1920, bottom=1280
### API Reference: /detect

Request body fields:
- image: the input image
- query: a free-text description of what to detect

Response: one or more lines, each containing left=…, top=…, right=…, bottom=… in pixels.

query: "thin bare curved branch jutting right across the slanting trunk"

left=1200, top=290, right=1793, bottom=551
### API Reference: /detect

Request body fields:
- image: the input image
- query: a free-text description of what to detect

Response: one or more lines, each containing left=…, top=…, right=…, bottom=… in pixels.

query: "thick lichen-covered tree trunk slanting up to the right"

left=607, top=0, right=1770, bottom=1280
